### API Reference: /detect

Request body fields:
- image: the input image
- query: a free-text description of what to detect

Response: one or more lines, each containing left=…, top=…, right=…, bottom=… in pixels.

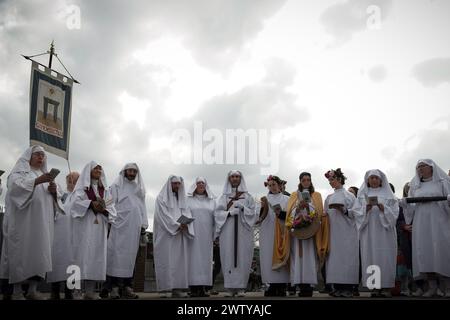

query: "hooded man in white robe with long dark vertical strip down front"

left=215, top=170, right=258, bottom=297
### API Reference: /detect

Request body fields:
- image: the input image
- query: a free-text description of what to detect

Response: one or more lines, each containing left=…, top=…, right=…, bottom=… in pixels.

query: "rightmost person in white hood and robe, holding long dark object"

left=402, top=159, right=450, bottom=297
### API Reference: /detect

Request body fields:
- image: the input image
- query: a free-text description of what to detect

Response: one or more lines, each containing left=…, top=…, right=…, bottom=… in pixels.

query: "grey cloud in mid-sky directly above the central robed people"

left=181, top=59, right=309, bottom=130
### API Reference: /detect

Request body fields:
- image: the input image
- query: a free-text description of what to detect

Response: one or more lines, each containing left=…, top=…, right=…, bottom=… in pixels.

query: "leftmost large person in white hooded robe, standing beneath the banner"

left=0, top=146, right=63, bottom=300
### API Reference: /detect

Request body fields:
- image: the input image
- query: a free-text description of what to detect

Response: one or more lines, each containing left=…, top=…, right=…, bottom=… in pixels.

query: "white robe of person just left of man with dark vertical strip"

left=187, top=195, right=216, bottom=286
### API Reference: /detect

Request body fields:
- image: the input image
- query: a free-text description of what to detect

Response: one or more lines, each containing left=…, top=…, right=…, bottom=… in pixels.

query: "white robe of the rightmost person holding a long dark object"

left=405, top=181, right=450, bottom=278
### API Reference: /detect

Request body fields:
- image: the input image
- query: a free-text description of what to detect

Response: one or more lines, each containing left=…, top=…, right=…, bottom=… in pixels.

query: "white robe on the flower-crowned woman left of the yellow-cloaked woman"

left=259, top=193, right=289, bottom=283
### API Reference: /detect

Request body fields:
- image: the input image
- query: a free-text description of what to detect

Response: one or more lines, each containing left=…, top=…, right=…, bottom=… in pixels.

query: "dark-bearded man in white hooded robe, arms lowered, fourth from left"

left=106, top=163, right=148, bottom=299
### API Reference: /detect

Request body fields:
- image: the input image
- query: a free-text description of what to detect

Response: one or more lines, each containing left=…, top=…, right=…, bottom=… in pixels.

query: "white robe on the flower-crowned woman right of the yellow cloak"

left=324, top=188, right=359, bottom=284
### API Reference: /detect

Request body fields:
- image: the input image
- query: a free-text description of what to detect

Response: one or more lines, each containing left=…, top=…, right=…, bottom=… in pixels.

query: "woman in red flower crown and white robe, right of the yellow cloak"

left=324, top=168, right=359, bottom=298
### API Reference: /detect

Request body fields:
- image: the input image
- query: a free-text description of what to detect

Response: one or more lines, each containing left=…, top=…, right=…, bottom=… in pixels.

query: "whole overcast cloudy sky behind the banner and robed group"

left=0, top=0, right=450, bottom=230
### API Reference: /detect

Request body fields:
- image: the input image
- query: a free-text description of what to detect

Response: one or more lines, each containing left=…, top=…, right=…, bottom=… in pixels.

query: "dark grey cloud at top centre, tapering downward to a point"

left=158, top=0, right=286, bottom=72
